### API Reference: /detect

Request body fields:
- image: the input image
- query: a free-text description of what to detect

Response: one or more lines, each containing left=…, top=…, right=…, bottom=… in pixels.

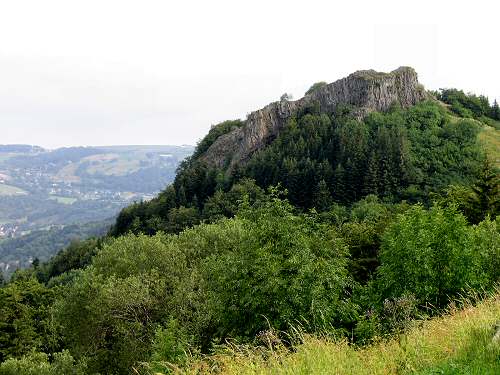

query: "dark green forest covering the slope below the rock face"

left=112, top=102, right=484, bottom=235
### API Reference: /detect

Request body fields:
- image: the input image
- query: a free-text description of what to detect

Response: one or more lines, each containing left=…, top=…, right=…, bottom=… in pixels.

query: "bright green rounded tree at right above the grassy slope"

left=376, top=205, right=485, bottom=308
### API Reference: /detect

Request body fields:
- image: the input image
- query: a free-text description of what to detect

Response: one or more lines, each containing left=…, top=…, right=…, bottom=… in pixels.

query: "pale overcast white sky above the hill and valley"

left=0, top=0, right=500, bottom=148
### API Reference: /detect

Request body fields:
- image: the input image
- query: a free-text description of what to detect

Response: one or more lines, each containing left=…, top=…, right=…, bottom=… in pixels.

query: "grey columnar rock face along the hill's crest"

left=201, top=67, right=427, bottom=170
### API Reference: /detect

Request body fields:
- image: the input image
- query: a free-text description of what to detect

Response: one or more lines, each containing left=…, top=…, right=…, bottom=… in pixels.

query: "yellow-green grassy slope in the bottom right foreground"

left=189, top=294, right=500, bottom=375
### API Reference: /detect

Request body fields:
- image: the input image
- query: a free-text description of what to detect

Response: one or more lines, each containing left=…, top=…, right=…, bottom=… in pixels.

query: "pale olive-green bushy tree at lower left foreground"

left=54, top=234, right=188, bottom=374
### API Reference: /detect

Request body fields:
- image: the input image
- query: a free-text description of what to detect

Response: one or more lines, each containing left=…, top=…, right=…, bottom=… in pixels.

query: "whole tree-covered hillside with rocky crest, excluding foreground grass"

left=0, top=68, right=500, bottom=375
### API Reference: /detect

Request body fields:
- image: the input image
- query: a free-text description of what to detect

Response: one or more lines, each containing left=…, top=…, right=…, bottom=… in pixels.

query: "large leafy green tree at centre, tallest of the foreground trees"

left=202, top=200, right=353, bottom=337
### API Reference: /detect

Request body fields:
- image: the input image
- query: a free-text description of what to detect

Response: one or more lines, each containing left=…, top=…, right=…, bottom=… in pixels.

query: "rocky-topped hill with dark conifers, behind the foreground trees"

left=113, top=67, right=499, bottom=235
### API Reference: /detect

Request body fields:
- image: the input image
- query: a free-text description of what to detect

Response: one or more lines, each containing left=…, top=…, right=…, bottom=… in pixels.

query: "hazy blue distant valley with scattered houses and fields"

left=0, top=145, right=193, bottom=273
